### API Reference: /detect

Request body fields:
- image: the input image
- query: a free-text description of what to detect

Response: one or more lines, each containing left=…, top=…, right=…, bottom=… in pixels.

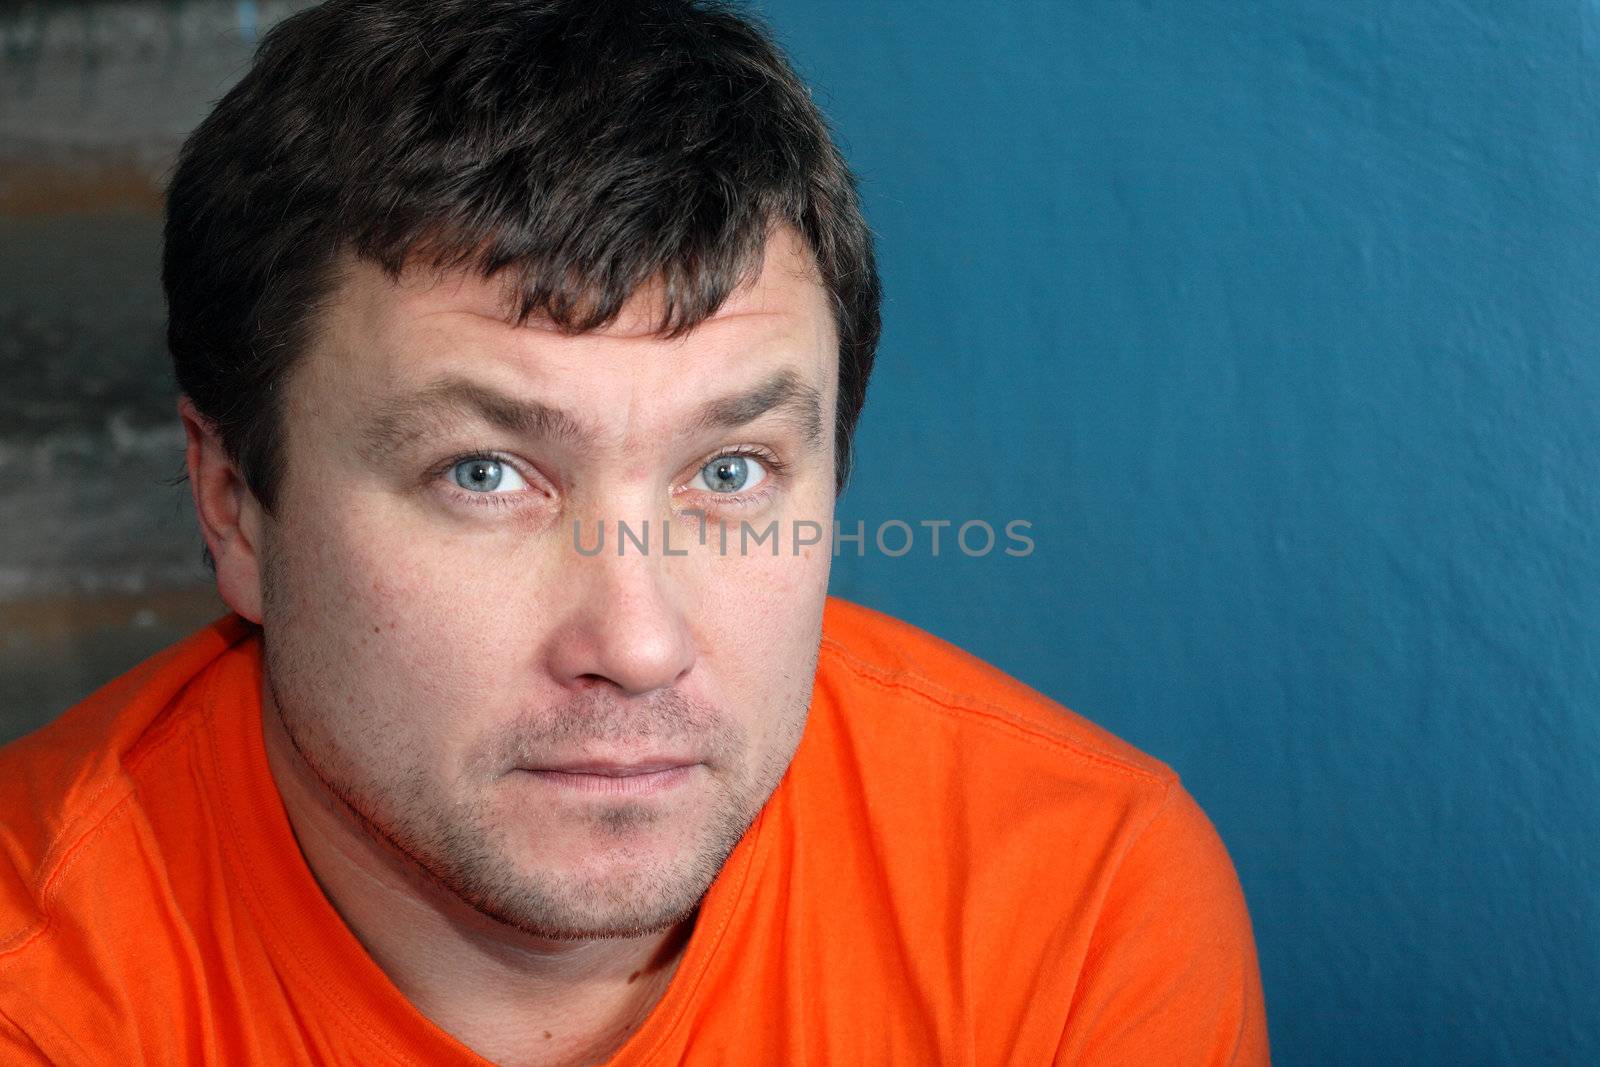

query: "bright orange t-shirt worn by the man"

left=0, top=600, right=1267, bottom=1067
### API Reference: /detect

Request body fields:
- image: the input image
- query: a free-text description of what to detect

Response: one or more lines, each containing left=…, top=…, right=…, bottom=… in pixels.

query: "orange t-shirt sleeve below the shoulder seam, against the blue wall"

left=1056, top=781, right=1269, bottom=1067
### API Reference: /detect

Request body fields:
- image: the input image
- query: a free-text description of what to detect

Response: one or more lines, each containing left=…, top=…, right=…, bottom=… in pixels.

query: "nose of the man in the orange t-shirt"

left=547, top=528, right=696, bottom=696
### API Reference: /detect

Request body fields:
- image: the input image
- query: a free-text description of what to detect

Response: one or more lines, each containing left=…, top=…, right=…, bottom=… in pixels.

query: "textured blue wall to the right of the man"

left=758, top=0, right=1600, bottom=1064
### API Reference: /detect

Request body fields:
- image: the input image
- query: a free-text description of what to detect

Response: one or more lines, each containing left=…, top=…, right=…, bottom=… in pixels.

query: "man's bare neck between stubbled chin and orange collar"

left=262, top=693, right=693, bottom=1067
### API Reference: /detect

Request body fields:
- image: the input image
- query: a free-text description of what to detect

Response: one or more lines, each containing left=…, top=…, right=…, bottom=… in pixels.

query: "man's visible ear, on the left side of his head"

left=178, top=397, right=266, bottom=624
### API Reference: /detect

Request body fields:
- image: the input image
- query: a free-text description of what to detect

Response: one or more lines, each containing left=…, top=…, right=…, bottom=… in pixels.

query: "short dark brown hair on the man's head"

left=162, top=0, right=880, bottom=509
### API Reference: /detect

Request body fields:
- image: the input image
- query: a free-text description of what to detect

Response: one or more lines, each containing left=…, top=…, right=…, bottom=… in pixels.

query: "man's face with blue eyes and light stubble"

left=252, top=230, right=837, bottom=937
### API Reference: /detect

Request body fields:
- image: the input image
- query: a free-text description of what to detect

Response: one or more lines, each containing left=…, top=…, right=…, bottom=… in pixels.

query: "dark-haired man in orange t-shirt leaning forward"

left=0, top=0, right=1267, bottom=1064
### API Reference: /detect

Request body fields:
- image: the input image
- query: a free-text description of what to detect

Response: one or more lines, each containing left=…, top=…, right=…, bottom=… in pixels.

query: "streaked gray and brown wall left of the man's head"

left=0, top=0, right=307, bottom=742
